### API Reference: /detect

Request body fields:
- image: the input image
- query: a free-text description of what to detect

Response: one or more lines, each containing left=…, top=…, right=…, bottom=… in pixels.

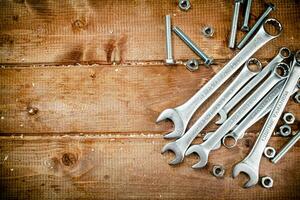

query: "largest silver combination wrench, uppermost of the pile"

left=156, top=19, right=282, bottom=138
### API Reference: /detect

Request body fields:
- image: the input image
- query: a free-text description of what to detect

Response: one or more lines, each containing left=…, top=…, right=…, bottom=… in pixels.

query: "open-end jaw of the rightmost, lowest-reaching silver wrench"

left=232, top=162, right=259, bottom=188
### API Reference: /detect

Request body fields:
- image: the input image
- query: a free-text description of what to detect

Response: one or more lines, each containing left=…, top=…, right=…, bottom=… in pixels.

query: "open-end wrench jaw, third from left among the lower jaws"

left=185, top=144, right=209, bottom=169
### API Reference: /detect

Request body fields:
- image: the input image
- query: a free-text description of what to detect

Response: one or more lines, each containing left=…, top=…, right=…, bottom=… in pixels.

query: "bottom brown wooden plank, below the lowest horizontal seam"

left=0, top=134, right=300, bottom=199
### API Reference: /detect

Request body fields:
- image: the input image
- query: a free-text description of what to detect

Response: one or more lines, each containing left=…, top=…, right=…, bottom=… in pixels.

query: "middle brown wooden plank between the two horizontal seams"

left=0, top=65, right=300, bottom=134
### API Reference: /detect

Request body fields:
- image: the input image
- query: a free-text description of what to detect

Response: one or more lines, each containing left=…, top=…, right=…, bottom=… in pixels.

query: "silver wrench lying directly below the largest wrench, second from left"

left=162, top=58, right=261, bottom=164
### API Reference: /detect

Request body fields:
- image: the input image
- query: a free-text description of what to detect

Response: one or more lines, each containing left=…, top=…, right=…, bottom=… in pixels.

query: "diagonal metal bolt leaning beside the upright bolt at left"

left=173, top=26, right=213, bottom=66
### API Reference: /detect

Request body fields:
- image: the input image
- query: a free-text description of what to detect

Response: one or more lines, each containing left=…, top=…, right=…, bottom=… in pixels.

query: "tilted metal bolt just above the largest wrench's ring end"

left=237, top=3, right=275, bottom=49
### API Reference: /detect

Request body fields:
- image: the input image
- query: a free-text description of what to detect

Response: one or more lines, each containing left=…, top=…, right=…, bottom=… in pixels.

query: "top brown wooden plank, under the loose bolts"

left=0, top=0, right=300, bottom=65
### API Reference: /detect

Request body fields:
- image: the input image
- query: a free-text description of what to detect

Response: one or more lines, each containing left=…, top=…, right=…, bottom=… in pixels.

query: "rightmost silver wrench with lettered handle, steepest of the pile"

left=233, top=51, right=300, bottom=188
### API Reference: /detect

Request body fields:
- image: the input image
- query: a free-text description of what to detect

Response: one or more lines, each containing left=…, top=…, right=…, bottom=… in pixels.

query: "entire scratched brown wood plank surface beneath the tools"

left=0, top=0, right=300, bottom=199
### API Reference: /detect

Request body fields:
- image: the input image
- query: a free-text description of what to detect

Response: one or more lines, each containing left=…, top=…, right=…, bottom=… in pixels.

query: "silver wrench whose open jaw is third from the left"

left=186, top=63, right=289, bottom=168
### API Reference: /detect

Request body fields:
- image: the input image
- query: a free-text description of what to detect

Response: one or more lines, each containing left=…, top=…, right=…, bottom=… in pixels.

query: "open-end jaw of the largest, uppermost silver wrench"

left=156, top=109, right=185, bottom=139
